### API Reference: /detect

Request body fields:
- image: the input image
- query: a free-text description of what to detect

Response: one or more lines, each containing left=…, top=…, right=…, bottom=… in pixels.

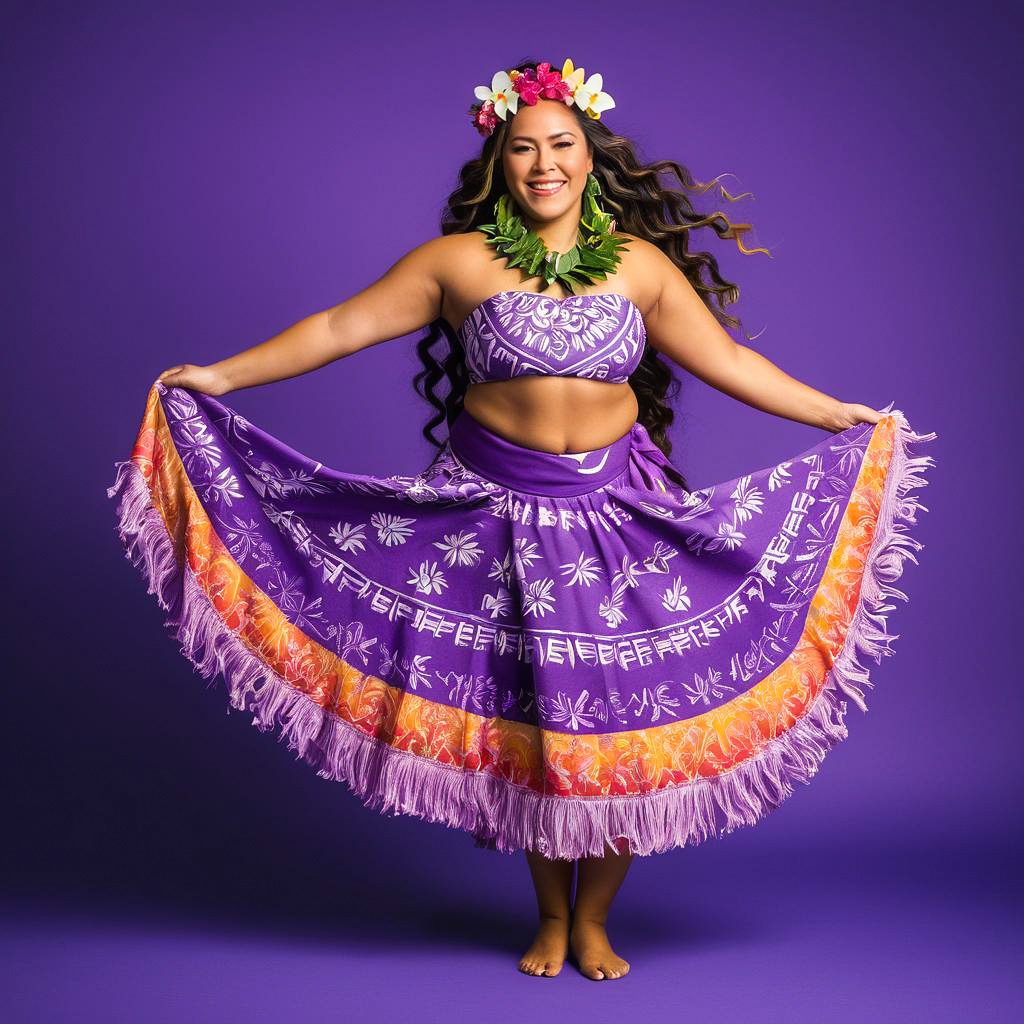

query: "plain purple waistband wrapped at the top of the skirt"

left=449, top=409, right=638, bottom=498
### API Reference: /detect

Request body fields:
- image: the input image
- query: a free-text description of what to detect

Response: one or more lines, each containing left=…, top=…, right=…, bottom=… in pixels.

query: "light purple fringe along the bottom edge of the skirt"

left=106, top=411, right=936, bottom=859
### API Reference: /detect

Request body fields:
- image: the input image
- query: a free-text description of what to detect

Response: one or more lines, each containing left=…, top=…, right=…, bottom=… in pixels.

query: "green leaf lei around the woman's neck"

left=478, top=174, right=629, bottom=293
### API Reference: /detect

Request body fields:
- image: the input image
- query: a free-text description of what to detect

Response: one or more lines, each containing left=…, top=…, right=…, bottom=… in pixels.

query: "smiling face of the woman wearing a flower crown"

left=502, top=99, right=594, bottom=222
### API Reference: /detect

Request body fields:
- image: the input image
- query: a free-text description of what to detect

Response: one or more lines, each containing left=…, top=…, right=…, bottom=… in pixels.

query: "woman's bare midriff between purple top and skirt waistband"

left=463, top=374, right=640, bottom=455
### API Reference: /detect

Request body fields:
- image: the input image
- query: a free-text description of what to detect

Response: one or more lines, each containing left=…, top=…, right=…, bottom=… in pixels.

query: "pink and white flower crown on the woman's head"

left=469, top=58, right=615, bottom=136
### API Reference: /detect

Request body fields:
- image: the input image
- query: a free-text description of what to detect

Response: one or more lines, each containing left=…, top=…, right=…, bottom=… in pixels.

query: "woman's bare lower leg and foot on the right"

left=569, top=847, right=633, bottom=981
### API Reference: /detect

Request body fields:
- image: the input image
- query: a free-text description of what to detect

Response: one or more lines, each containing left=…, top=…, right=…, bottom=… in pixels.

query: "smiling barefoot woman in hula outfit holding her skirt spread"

left=109, top=61, right=935, bottom=979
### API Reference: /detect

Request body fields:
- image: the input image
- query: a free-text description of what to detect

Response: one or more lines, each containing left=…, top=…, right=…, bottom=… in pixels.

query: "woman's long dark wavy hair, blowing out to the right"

left=413, top=60, right=770, bottom=489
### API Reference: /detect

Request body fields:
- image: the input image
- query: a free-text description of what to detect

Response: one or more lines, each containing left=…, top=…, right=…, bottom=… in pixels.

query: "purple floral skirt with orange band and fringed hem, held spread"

left=108, top=381, right=936, bottom=858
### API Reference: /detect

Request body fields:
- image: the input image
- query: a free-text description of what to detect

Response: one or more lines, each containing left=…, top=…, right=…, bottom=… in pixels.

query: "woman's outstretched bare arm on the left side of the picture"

left=158, top=236, right=458, bottom=395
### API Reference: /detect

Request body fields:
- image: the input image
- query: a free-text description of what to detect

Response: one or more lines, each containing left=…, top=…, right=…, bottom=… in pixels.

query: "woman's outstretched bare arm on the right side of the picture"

left=643, top=245, right=884, bottom=433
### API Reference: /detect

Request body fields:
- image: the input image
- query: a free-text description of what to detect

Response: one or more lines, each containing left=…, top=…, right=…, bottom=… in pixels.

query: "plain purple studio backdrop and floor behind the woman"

left=0, top=2, right=1024, bottom=1021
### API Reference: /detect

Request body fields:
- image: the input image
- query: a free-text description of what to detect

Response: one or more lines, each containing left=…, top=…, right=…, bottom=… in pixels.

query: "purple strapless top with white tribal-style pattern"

left=459, top=291, right=647, bottom=382
